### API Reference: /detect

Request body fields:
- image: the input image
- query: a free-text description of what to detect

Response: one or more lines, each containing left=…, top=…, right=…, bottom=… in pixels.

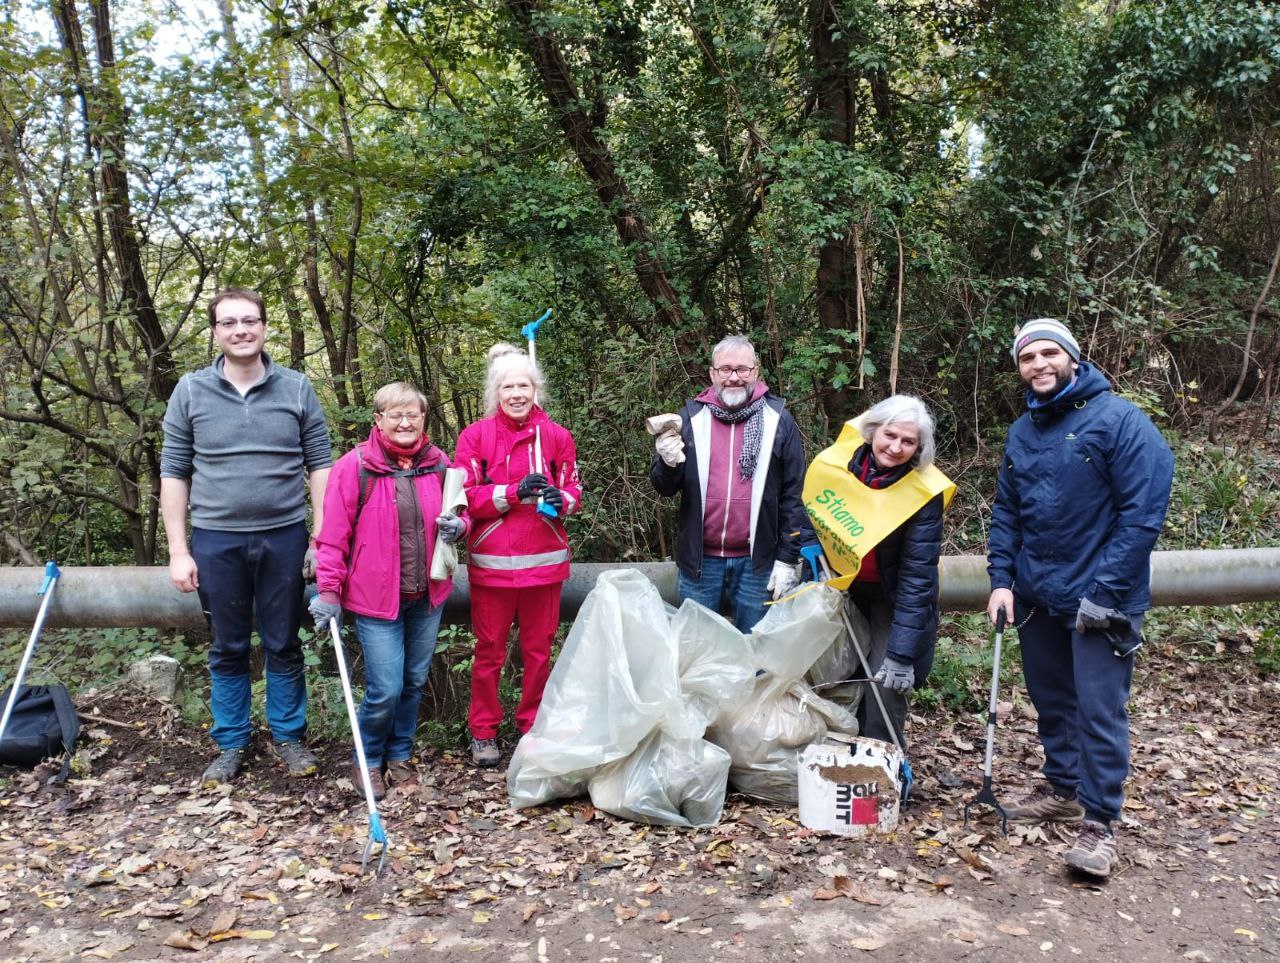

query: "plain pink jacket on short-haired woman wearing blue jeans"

left=316, top=429, right=465, bottom=619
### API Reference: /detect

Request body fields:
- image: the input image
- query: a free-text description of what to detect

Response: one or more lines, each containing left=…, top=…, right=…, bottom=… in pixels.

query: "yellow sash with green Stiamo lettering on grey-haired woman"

left=803, top=421, right=956, bottom=590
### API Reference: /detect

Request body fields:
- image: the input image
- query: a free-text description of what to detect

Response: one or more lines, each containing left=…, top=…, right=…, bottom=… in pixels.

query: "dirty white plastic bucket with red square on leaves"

left=799, top=739, right=902, bottom=839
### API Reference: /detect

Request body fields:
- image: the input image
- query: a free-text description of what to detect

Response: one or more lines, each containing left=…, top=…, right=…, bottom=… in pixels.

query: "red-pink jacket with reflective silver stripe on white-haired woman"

left=458, top=406, right=582, bottom=587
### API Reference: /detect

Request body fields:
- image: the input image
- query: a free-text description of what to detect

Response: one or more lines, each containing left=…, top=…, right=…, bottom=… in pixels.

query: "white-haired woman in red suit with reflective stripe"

left=458, top=344, right=582, bottom=766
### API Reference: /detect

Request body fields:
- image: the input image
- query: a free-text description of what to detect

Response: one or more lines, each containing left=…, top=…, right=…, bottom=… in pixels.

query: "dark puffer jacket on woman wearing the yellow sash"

left=850, top=444, right=942, bottom=689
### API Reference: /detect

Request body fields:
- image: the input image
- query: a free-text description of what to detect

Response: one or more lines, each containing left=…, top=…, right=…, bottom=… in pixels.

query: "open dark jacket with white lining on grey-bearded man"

left=649, top=393, right=817, bottom=579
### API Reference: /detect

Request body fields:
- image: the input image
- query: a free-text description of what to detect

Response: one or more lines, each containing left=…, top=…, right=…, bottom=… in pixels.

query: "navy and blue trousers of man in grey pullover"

left=191, top=521, right=307, bottom=749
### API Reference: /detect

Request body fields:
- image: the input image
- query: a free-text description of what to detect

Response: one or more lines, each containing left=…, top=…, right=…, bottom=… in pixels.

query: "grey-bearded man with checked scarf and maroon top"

left=649, top=334, right=813, bottom=633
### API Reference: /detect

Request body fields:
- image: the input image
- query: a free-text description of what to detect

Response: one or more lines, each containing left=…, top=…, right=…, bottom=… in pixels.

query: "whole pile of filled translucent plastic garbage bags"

left=507, top=570, right=856, bottom=826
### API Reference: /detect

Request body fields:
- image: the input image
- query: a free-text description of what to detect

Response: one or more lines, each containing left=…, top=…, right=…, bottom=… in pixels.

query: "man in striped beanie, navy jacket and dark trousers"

left=987, top=318, right=1174, bottom=878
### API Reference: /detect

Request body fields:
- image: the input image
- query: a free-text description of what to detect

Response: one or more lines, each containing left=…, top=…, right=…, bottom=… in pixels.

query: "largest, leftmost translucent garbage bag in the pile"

left=507, top=569, right=681, bottom=809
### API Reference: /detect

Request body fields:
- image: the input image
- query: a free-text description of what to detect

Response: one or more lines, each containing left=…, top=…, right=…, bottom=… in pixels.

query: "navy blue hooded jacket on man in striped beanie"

left=987, top=364, right=1174, bottom=616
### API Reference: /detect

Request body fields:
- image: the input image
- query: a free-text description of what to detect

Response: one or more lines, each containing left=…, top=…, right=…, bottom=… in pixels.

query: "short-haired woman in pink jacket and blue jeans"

left=311, top=382, right=467, bottom=799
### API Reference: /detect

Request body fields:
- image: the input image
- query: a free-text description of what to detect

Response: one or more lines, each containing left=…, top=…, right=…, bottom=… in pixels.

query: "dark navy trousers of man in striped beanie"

left=1015, top=598, right=1142, bottom=823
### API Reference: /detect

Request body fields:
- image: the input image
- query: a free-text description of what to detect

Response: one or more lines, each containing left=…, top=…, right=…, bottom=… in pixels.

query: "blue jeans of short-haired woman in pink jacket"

left=356, top=595, right=444, bottom=768
